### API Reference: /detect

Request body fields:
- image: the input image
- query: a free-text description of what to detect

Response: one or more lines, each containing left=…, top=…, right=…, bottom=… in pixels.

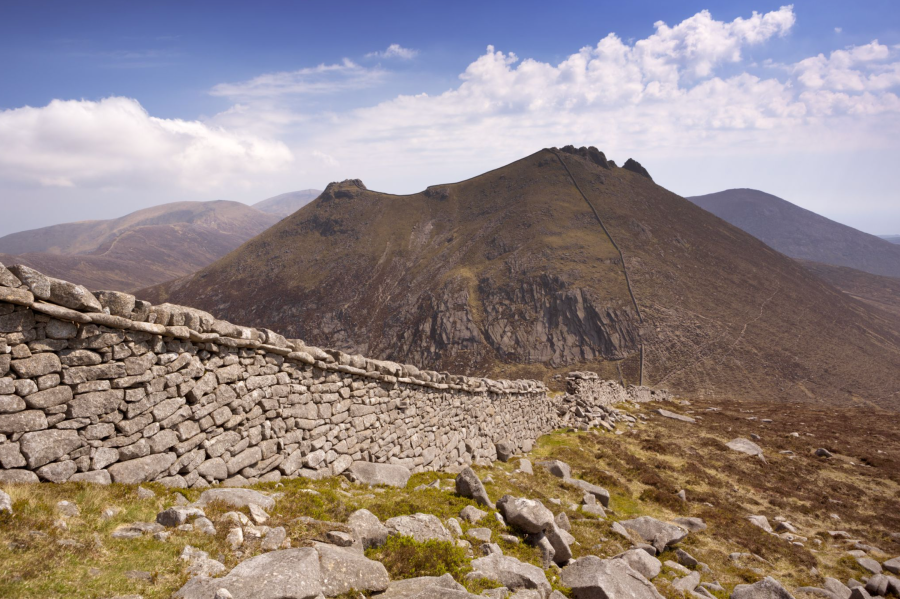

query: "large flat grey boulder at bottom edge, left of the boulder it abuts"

left=173, top=547, right=323, bottom=599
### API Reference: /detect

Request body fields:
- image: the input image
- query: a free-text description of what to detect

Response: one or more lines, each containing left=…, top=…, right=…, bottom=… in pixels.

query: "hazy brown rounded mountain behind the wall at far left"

left=0, top=200, right=278, bottom=291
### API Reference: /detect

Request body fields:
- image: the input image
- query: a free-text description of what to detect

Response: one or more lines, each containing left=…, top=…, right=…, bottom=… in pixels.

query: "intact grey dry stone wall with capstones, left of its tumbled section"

left=0, top=265, right=561, bottom=486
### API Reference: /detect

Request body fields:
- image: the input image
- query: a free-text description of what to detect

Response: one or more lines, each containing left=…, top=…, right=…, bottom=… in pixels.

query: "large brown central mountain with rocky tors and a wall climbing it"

left=139, top=146, right=900, bottom=408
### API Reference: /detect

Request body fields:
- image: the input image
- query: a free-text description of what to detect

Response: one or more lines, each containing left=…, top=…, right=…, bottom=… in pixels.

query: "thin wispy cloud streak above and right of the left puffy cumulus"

left=210, top=58, right=385, bottom=98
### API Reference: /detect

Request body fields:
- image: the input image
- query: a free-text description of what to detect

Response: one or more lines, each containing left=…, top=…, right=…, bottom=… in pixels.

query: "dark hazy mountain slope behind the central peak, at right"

left=687, top=189, right=900, bottom=277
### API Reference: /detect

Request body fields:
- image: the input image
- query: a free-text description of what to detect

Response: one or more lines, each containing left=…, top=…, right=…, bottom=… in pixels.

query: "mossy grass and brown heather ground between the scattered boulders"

left=0, top=396, right=900, bottom=599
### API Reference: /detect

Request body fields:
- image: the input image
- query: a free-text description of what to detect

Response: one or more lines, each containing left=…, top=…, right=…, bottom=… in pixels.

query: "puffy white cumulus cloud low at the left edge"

left=0, top=97, right=293, bottom=191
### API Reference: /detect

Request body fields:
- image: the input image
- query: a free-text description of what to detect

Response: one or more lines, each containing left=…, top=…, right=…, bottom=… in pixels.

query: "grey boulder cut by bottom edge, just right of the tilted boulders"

left=560, top=555, right=662, bottom=599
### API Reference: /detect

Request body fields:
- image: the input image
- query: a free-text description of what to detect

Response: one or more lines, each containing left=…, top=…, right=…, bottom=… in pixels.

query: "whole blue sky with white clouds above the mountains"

left=0, top=0, right=900, bottom=235
